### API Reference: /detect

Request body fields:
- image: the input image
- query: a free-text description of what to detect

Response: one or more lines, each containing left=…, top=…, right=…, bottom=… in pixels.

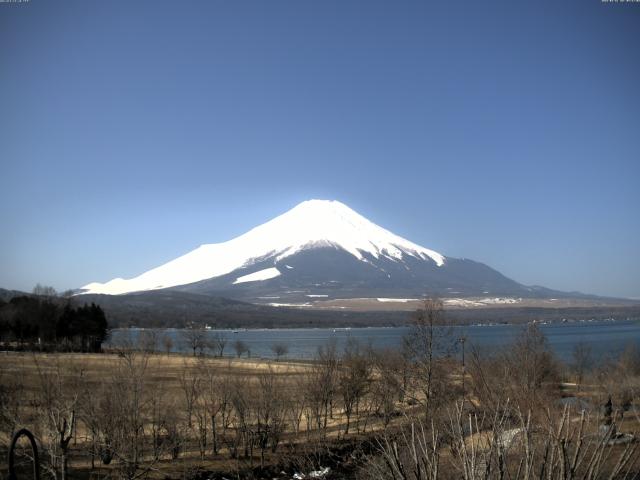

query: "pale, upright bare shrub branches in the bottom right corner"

left=368, top=402, right=640, bottom=480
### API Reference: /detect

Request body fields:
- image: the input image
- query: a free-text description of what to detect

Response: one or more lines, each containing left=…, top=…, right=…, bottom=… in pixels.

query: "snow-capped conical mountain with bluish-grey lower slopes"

left=79, top=200, right=568, bottom=305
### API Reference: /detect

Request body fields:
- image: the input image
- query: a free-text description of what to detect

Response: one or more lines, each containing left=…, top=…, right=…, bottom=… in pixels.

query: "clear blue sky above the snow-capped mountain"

left=0, top=0, right=640, bottom=297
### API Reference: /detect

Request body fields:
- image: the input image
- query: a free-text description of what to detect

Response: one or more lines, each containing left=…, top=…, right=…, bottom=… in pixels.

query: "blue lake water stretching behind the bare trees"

left=107, top=320, right=640, bottom=361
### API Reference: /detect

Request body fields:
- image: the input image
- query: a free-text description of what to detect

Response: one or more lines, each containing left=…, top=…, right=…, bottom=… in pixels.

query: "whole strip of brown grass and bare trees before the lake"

left=0, top=301, right=640, bottom=480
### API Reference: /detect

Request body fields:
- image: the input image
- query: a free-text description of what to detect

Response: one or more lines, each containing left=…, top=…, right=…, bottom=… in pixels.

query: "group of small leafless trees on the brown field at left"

left=0, top=334, right=416, bottom=480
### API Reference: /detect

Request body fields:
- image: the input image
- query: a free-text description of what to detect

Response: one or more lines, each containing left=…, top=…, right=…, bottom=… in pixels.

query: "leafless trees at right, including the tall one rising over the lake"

left=366, top=302, right=640, bottom=480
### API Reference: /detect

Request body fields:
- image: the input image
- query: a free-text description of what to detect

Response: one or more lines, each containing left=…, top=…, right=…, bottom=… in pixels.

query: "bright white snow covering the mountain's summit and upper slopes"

left=82, top=200, right=446, bottom=295
